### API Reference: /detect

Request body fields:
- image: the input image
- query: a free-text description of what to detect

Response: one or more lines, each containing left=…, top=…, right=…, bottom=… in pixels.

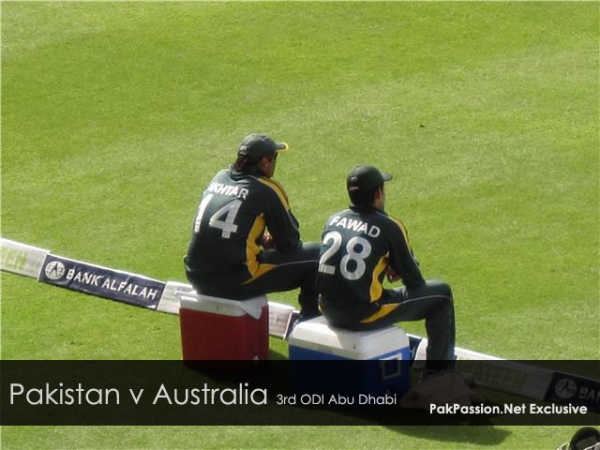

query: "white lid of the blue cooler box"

left=289, top=316, right=409, bottom=359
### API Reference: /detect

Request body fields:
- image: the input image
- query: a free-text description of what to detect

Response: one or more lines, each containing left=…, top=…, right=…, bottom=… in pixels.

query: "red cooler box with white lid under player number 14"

left=179, top=295, right=269, bottom=361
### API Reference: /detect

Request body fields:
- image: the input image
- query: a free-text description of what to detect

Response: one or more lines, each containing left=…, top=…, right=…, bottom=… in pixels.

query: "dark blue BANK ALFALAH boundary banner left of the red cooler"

left=39, top=255, right=165, bottom=309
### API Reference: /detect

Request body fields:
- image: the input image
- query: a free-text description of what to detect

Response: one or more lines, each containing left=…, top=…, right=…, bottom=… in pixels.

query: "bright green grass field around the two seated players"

left=0, top=1, right=600, bottom=449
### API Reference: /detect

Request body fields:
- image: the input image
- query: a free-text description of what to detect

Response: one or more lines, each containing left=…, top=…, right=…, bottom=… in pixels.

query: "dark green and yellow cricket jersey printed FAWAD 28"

left=318, top=207, right=425, bottom=321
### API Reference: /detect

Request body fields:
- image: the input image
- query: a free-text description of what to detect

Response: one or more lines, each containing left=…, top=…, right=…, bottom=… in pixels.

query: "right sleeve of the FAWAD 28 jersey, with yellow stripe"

left=390, top=217, right=425, bottom=288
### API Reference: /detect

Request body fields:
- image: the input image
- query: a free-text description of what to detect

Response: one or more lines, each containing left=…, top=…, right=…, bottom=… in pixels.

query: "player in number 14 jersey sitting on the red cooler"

left=185, top=134, right=319, bottom=317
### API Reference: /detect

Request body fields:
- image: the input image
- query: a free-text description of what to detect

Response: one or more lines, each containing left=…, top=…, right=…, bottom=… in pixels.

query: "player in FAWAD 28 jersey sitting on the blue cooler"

left=318, top=165, right=455, bottom=369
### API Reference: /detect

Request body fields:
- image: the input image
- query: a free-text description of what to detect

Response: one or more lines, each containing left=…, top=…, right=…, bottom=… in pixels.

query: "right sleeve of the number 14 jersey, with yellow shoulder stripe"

left=260, top=178, right=300, bottom=252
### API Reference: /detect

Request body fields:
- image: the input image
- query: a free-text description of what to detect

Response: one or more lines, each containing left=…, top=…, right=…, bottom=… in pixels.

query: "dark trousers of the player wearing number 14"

left=186, top=242, right=320, bottom=318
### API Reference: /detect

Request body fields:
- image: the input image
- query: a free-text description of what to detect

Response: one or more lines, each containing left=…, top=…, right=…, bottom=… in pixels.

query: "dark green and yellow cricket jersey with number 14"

left=185, top=167, right=301, bottom=284
